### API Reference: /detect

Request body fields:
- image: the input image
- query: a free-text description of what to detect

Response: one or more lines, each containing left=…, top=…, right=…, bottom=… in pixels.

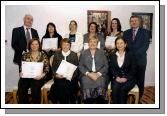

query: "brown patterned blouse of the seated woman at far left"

left=22, top=51, right=49, bottom=74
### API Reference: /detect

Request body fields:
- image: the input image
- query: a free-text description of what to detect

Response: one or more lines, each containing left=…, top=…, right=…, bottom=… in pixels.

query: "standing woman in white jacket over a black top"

left=65, top=20, right=83, bottom=54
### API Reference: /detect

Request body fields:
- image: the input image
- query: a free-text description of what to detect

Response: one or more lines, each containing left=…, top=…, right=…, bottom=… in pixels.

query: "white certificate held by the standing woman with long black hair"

left=42, top=38, right=58, bottom=49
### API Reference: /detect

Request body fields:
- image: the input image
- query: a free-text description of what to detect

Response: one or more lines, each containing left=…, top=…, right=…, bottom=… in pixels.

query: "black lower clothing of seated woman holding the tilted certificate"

left=49, top=78, right=79, bottom=104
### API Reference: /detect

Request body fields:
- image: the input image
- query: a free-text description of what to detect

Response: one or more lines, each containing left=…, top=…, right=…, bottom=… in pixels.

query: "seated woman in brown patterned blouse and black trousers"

left=17, top=39, right=49, bottom=104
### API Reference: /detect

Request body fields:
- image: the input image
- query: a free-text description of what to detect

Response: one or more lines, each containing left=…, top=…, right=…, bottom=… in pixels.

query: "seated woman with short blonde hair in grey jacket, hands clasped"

left=79, top=36, right=108, bottom=104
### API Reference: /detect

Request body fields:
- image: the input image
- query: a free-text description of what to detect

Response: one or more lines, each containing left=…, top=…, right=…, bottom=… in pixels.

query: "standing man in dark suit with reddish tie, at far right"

left=123, top=16, right=150, bottom=100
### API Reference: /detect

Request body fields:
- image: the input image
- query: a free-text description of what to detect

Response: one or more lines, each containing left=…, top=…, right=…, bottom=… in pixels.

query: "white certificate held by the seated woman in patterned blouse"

left=22, top=61, right=43, bottom=78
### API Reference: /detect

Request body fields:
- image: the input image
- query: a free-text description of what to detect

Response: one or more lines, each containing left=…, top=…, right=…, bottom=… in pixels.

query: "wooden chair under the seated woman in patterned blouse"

left=13, top=86, right=43, bottom=104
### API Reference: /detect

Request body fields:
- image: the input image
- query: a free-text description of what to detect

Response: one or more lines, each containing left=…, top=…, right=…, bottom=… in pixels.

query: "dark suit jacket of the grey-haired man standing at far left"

left=11, top=26, right=39, bottom=66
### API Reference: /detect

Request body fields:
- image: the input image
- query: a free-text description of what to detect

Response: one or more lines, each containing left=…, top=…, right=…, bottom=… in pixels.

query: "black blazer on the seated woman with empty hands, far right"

left=110, top=52, right=136, bottom=80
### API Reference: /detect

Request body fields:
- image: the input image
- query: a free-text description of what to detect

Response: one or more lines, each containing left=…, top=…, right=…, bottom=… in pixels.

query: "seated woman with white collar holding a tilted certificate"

left=49, top=38, right=79, bottom=104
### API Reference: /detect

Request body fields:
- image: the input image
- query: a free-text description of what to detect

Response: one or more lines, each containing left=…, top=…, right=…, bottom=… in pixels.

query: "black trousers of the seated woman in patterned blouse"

left=17, top=78, right=45, bottom=104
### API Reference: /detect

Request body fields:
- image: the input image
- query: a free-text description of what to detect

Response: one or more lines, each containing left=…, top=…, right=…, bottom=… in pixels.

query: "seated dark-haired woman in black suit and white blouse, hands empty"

left=110, top=37, right=136, bottom=104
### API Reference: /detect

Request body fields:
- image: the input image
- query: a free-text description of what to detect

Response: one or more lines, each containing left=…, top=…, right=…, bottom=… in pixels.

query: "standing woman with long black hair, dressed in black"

left=41, top=22, right=62, bottom=81
